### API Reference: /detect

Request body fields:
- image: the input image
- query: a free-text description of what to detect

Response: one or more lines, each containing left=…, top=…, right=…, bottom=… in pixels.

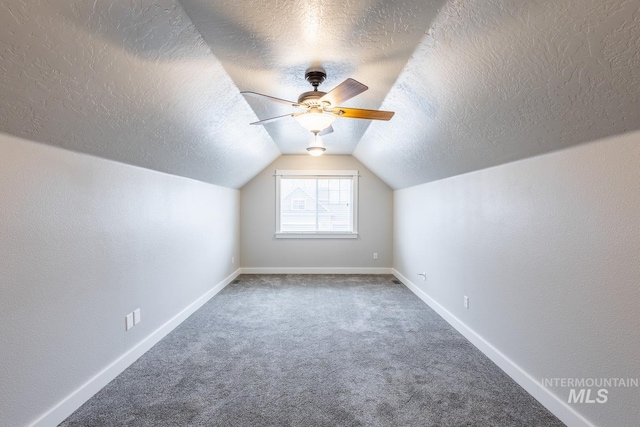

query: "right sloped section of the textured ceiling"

left=354, top=0, right=640, bottom=188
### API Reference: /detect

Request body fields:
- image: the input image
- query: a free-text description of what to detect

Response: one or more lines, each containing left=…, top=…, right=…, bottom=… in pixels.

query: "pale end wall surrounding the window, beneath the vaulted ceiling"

left=240, top=155, right=393, bottom=273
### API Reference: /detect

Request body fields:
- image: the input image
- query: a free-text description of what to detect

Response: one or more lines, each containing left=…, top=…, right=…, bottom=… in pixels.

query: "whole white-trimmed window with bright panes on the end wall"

left=276, top=170, right=358, bottom=238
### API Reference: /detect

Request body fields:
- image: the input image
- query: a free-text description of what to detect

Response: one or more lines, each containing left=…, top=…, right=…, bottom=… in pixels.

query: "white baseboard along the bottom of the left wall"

left=30, top=269, right=240, bottom=427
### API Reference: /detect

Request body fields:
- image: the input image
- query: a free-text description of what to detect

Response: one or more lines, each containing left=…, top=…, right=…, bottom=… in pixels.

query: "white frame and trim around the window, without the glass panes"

left=275, top=169, right=360, bottom=239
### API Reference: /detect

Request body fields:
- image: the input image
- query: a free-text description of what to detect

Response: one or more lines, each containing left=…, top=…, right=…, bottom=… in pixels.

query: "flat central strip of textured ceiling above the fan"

left=180, top=0, right=444, bottom=154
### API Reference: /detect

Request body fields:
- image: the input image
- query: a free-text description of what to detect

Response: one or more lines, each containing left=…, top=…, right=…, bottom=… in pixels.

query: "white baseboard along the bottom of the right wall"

left=391, top=268, right=593, bottom=427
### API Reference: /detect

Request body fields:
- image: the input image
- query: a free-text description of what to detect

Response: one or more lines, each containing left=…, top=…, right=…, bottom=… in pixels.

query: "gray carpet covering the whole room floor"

left=61, top=275, right=563, bottom=427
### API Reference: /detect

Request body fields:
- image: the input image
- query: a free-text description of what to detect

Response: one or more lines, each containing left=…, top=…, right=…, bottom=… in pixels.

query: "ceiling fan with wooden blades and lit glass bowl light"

left=240, top=69, right=394, bottom=137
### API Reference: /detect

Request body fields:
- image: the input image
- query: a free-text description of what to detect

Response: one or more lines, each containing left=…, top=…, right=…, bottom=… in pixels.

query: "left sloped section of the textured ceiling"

left=0, top=0, right=280, bottom=188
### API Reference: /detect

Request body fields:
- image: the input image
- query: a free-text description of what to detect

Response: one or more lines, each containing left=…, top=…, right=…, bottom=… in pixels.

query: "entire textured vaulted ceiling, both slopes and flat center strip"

left=0, top=0, right=640, bottom=188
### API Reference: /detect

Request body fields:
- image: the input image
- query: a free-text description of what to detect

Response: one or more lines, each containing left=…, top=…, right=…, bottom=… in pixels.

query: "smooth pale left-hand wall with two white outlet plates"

left=0, top=134, right=239, bottom=426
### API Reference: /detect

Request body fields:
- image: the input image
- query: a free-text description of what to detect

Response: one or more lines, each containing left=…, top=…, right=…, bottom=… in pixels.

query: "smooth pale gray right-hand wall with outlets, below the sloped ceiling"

left=394, top=133, right=640, bottom=426
